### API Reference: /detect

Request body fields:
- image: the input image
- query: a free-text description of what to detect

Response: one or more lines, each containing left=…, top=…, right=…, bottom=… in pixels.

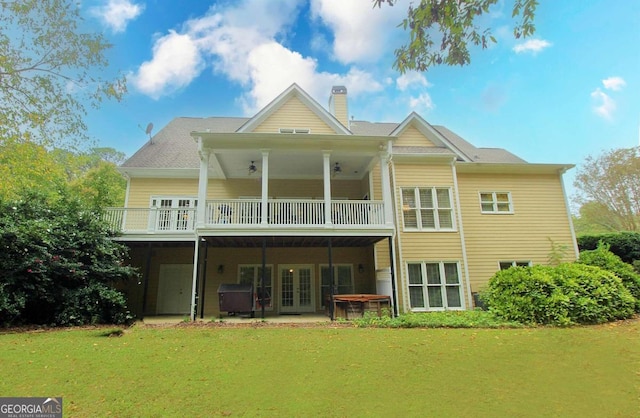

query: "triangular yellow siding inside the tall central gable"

left=253, top=97, right=335, bottom=135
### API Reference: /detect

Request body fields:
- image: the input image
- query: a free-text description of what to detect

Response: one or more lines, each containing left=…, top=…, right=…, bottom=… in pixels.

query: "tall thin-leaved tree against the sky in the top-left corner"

left=0, top=0, right=126, bottom=146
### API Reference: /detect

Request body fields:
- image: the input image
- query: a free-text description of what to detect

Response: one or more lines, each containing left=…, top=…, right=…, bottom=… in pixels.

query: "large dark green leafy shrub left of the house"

left=0, top=192, right=137, bottom=326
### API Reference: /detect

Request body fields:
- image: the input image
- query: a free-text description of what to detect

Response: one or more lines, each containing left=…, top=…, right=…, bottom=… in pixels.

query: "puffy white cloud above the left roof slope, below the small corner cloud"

left=129, top=31, right=203, bottom=99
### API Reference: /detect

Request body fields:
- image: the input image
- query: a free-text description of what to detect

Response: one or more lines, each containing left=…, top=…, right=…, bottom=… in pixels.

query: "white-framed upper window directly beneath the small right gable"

left=401, top=187, right=454, bottom=231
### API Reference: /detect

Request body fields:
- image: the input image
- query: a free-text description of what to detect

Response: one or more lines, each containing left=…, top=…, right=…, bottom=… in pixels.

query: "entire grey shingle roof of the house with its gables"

left=122, top=84, right=526, bottom=173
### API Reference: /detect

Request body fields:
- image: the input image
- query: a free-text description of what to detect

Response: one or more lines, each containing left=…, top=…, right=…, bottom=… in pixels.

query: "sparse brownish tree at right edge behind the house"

left=574, top=147, right=640, bottom=231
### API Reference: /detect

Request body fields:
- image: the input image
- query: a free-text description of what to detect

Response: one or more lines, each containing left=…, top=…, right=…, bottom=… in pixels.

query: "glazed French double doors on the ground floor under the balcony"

left=279, top=264, right=316, bottom=313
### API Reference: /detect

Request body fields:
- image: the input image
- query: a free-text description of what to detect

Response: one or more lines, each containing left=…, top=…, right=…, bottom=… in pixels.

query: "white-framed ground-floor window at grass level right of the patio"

left=407, top=261, right=464, bottom=311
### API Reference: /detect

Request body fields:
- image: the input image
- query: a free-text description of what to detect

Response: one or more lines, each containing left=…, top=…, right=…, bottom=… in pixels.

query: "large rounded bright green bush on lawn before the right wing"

left=482, top=263, right=635, bottom=325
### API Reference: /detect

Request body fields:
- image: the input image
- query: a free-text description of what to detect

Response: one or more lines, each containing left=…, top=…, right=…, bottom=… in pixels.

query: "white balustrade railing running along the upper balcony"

left=105, top=199, right=388, bottom=235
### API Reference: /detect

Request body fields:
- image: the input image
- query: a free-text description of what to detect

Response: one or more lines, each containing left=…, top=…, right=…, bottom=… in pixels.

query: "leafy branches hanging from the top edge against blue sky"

left=373, top=0, right=538, bottom=74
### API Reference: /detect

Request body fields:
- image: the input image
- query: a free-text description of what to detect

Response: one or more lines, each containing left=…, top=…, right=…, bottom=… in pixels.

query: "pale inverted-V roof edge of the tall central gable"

left=237, top=83, right=351, bottom=135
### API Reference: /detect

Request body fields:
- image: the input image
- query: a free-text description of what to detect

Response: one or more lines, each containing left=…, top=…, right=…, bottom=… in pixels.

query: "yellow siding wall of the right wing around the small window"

left=458, top=170, right=575, bottom=291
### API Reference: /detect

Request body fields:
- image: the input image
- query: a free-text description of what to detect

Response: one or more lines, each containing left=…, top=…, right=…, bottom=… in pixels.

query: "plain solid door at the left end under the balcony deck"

left=156, top=264, right=193, bottom=315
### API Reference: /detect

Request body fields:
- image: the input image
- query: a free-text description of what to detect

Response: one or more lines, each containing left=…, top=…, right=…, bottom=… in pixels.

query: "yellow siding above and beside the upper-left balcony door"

left=128, top=178, right=198, bottom=208
